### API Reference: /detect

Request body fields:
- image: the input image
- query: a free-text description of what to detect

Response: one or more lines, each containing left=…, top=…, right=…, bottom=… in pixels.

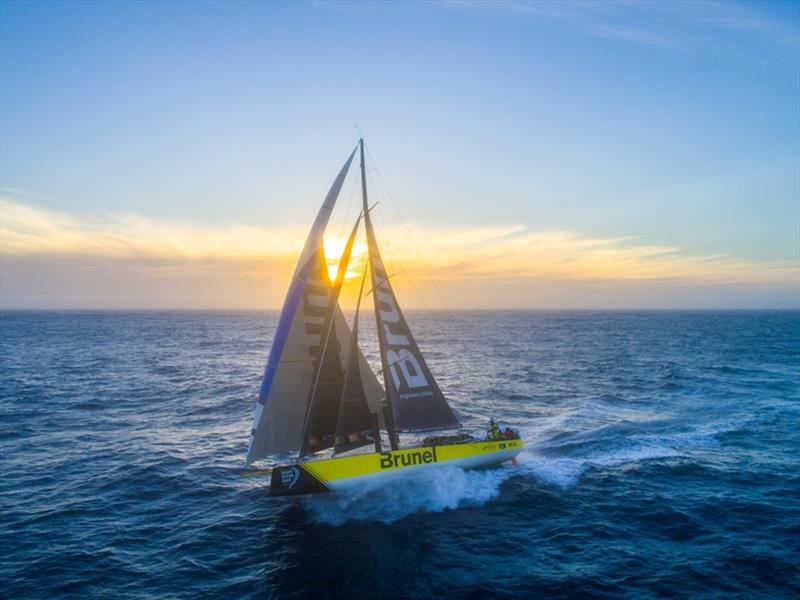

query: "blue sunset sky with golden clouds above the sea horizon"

left=0, top=0, right=800, bottom=310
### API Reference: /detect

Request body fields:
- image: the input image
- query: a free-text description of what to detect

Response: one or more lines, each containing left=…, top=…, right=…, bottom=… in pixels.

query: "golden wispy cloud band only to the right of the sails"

left=376, top=227, right=798, bottom=284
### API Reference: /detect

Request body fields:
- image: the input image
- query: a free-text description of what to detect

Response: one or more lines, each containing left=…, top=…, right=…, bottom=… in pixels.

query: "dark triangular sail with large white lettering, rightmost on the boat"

left=361, top=140, right=461, bottom=431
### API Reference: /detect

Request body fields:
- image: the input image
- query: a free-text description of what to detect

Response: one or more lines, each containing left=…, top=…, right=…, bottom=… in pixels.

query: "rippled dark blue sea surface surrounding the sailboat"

left=0, top=311, right=800, bottom=599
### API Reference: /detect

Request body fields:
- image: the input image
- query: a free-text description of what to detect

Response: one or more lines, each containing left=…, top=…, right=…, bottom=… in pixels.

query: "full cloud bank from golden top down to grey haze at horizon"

left=0, top=199, right=800, bottom=308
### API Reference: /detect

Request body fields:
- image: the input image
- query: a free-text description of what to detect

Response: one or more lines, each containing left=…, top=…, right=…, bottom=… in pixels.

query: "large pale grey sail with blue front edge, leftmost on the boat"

left=247, top=145, right=383, bottom=464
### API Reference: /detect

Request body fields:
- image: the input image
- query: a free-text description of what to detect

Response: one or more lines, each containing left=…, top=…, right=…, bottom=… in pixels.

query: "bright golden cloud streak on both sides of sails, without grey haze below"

left=0, top=199, right=798, bottom=294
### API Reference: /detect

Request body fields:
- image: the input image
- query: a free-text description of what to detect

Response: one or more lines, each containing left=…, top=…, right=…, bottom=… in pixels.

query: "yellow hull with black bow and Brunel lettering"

left=270, top=440, right=523, bottom=496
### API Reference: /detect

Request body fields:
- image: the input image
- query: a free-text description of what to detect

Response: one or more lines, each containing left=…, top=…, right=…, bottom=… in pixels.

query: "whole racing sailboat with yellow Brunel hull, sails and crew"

left=246, top=139, right=523, bottom=496
